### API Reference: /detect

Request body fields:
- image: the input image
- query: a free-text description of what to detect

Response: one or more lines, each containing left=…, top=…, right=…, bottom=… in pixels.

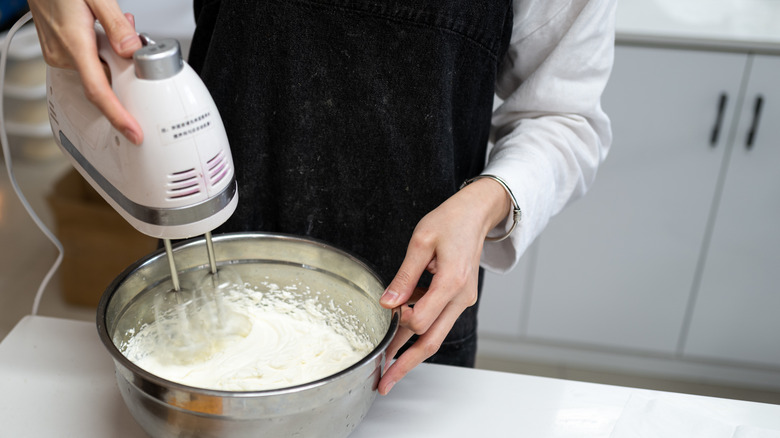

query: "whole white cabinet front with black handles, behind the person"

left=480, top=46, right=780, bottom=388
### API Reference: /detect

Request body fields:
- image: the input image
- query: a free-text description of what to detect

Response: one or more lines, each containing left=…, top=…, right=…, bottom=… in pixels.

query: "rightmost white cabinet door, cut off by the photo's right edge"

left=684, top=56, right=780, bottom=367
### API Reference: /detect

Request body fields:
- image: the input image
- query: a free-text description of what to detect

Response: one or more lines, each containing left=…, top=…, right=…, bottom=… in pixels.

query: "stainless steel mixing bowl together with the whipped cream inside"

left=97, top=233, right=398, bottom=438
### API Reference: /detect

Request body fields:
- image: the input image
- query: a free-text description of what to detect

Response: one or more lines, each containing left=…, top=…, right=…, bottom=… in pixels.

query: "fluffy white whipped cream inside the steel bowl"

left=120, top=284, right=374, bottom=391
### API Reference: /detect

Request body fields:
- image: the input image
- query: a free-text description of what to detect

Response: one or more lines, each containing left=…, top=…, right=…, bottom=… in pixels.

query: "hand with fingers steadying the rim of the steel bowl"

left=378, top=178, right=510, bottom=395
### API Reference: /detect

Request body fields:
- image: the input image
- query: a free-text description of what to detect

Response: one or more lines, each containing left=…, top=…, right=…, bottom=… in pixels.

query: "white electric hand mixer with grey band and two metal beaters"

left=46, top=24, right=248, bottom=360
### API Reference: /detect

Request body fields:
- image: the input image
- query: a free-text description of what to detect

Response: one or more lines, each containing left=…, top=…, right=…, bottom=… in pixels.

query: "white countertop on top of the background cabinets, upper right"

left=616, top=0, right=780, bottom=54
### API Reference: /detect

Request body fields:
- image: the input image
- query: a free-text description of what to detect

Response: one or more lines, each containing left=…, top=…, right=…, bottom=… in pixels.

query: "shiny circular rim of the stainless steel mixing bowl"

left=96, top=232, right=400, bottom=398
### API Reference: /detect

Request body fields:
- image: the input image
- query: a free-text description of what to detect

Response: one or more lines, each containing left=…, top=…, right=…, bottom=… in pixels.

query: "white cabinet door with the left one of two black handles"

left=528, top=47, right=747, bottom=353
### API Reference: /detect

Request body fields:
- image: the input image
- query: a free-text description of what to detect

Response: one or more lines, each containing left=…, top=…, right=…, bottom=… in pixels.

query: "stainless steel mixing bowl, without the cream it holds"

left=97, top=233, right=398, bottom=438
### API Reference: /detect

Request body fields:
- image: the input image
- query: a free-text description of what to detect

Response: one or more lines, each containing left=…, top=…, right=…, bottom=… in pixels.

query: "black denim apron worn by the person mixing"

left=189, top=0, right=512, bottom=366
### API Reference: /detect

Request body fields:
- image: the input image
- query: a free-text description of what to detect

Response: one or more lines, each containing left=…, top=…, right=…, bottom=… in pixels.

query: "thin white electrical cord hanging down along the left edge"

left=0, top=12, right=64, bottom=315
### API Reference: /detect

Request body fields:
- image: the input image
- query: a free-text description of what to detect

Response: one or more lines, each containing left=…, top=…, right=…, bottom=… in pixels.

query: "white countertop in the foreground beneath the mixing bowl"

left=0, top=316, right=780, bottom=438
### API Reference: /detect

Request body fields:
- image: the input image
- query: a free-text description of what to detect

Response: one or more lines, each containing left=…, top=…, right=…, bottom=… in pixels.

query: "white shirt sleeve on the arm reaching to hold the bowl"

left=481, top=0, right=616, bottom=273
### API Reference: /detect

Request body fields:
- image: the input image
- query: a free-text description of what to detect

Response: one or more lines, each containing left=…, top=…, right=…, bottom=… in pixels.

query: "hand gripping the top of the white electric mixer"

left=28, top=0, right=143, bottom=144
